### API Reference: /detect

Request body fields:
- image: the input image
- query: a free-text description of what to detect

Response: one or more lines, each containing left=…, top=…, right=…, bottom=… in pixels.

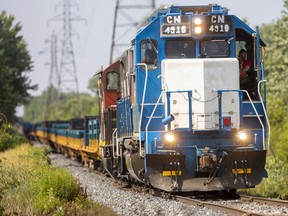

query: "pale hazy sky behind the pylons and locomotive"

left=0, top=0, right=283, bottom=96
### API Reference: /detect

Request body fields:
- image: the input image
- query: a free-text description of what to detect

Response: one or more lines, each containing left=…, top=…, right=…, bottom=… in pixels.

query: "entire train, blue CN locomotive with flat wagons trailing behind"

left=33, top=4, right=269, bottom=192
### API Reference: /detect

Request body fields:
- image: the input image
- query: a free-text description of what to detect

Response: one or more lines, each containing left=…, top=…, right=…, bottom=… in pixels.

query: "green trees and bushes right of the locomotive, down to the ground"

left=240, top=0, right=288, bottom=199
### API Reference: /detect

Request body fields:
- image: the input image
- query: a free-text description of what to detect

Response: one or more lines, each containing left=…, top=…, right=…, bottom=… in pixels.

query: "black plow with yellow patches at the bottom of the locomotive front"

left=145, top=151, right=266, bottom=192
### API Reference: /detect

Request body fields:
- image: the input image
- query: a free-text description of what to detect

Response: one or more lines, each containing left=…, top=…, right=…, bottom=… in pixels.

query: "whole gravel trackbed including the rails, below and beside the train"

left=45, top=143, right=288, bottom=216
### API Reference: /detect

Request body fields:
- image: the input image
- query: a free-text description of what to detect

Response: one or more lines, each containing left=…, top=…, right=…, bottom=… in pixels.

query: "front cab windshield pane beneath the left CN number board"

left=165, top=40, right=195, bottom=59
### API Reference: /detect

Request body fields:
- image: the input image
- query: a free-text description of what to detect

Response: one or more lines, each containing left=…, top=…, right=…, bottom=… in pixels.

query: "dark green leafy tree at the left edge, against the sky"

left=0, top=11, right=37, bottom=122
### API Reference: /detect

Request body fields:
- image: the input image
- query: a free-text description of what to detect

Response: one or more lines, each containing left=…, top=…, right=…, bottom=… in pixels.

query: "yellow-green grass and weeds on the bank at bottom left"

left=0, top=144, right=116, bottom=215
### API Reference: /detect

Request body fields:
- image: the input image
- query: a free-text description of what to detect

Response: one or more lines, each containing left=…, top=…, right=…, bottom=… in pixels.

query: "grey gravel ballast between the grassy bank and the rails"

left=50, top=154, right=226, bottom=216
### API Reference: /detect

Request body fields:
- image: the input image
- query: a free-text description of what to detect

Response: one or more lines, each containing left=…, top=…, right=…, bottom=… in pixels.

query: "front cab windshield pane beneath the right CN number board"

left=200, top=40, right=230, bottom=58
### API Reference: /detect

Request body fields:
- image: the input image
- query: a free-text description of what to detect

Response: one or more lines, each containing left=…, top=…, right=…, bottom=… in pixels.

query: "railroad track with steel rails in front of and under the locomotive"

left=109, top=169, right=288, bottom=216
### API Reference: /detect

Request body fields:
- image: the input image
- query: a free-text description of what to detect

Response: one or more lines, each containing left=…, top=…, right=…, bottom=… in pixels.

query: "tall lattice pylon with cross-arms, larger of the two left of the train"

left=51, top=0, right=84, bottom=118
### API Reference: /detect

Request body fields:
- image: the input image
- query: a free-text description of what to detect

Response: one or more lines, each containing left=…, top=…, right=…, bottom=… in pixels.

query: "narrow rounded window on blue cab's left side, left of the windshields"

left=141, top=39, right=158, bottom=70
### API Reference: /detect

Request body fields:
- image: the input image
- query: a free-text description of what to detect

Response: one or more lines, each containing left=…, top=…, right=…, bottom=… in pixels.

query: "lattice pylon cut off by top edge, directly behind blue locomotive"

left=110, top=0, right=155, bottom=64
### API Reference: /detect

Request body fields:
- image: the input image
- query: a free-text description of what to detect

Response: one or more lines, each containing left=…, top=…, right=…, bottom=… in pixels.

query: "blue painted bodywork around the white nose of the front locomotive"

left=125, top=5, right=266, bottom=191
